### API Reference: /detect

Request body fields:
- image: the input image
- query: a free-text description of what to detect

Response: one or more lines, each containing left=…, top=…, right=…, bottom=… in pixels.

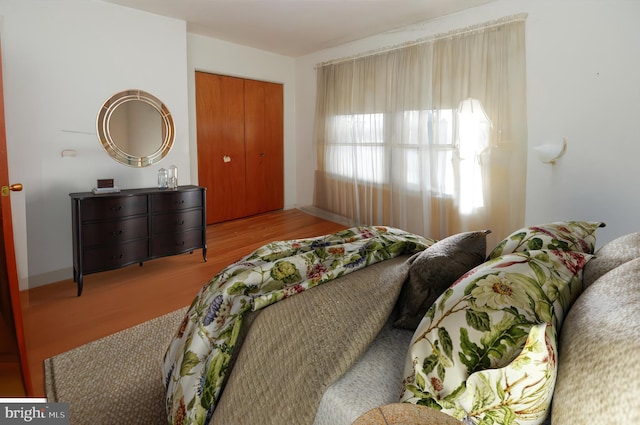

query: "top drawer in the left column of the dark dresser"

left=80, top=195, right=147, bottom=222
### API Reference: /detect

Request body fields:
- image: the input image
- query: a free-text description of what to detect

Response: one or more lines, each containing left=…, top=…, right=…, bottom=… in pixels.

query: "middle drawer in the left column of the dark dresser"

left=82, top=216, right=148, bottom=247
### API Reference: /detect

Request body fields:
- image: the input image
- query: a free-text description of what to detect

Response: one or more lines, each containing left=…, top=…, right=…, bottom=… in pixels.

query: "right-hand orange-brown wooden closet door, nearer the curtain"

left=244, top=80, right=284, bottom=215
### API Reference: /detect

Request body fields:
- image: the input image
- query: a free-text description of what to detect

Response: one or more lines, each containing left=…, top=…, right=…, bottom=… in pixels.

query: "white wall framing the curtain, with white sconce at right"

left=296, top=0, right=640, bottom=244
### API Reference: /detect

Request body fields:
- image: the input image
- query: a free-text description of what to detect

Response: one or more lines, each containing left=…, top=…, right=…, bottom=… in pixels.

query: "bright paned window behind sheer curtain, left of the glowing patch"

left=325, top=109, right=455, bottom=197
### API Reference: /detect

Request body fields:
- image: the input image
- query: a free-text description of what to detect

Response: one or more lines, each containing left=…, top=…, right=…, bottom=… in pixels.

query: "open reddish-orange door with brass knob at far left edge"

left=0, top=43, right=32, bottom=395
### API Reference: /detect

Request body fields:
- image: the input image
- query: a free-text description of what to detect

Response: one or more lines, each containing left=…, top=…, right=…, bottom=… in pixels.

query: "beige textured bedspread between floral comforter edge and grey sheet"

left=210, top=256, right=408, bottom=425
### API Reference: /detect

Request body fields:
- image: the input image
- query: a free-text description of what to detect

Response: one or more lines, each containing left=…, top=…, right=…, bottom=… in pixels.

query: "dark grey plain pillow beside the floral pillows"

left=394, top=230, right=491, bottom=331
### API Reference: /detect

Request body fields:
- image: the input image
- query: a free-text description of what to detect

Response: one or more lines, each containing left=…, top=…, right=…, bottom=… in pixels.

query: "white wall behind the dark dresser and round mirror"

left=0, top=0, right=190, bottom=289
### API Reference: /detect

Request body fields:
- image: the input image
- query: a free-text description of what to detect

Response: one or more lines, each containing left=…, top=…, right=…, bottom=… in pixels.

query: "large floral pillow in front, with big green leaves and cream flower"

left=401, top=250, right=593, bottom=418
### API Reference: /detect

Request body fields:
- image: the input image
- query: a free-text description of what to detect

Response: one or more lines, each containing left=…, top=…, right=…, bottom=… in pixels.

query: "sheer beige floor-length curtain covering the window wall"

left=314, top=16, right=527, bottom=242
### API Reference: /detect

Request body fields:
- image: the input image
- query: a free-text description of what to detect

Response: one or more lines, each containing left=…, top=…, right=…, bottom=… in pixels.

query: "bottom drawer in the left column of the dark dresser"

left=82, top=239, right=149, bottom=273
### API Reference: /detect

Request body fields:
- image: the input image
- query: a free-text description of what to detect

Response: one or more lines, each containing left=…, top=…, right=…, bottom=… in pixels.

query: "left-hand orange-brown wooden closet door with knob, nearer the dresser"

left=195, top=72, right=246, bottom=224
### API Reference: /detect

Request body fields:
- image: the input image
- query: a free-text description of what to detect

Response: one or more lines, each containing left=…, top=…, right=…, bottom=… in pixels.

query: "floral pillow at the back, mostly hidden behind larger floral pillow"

left=488, top=221, right=605, bottom=259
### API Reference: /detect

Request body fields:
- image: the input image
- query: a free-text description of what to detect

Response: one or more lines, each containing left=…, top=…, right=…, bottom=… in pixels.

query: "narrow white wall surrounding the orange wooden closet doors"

left=188, top=34, right=296, bottom=208
